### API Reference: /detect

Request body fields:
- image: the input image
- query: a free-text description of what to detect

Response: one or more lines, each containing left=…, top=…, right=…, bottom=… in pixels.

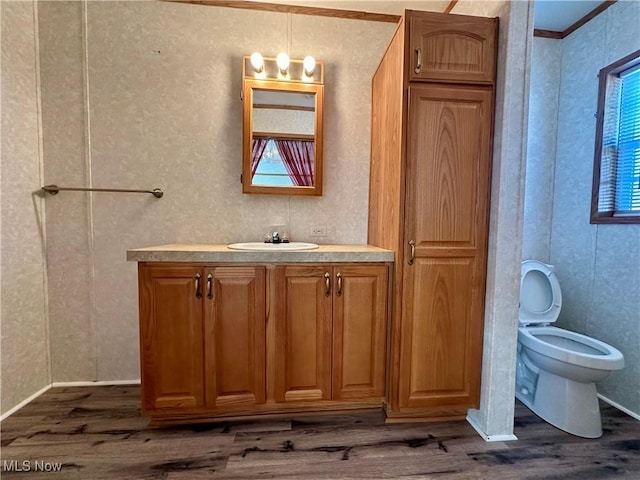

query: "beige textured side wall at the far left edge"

left=0, top=1, right=50, bottom=414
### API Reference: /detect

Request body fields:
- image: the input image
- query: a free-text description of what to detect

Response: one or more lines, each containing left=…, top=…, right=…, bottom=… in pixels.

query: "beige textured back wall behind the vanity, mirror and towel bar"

left=40, top=2, right=394, bottom=381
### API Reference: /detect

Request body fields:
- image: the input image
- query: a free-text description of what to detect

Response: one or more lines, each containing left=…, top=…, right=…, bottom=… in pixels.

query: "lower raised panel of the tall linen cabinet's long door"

left=401, top=257, right=479, bottom=407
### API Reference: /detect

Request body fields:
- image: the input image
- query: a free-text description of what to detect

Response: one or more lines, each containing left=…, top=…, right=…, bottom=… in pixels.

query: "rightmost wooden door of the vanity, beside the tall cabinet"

left=332, top=265, right=389, bottom=401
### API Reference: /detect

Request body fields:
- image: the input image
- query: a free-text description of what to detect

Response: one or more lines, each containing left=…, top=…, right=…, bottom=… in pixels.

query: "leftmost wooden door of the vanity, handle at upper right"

left=138, top=264, right=204, bottom=413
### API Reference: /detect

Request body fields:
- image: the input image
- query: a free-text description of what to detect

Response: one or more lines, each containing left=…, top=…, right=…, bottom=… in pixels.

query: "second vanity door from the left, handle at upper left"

left=204, top=266, right=266, bottom=409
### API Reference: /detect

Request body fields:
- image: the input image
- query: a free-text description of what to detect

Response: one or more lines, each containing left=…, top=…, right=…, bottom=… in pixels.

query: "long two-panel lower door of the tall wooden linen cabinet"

left=399, top=85, right=492, bottom=416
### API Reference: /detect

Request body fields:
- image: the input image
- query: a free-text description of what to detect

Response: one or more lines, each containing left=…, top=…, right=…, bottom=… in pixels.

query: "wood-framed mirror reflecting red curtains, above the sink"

left=242, top=57, right=324, bottom=195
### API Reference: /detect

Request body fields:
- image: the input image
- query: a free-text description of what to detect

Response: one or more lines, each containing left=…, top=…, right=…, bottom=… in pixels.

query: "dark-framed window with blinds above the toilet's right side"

left=591, top=50, right=640, bottom=223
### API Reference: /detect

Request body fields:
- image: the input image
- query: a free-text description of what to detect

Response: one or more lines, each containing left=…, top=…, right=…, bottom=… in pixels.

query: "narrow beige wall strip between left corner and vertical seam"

left=39, top=2, right=96, bottom=382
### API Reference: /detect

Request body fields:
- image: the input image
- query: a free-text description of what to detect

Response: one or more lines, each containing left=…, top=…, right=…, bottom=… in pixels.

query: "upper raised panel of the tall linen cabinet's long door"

left=409, top=87, right=491, bottom=249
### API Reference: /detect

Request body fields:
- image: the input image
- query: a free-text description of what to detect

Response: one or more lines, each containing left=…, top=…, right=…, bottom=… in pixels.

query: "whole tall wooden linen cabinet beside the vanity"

left=368, top=10, right=498, bottom=421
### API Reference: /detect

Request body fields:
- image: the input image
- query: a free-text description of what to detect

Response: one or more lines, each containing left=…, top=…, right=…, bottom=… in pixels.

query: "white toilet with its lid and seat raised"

left=516, top=260, right=624, bottom=438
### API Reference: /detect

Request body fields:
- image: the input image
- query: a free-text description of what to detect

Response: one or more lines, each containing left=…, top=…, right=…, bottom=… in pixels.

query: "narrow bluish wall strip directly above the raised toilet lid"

left=522, top=37, right=562, bottom=263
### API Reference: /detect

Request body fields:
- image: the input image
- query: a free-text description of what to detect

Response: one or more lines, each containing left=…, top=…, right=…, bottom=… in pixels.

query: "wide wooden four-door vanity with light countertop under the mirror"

left=127, top=245, right=394, bottom=424
